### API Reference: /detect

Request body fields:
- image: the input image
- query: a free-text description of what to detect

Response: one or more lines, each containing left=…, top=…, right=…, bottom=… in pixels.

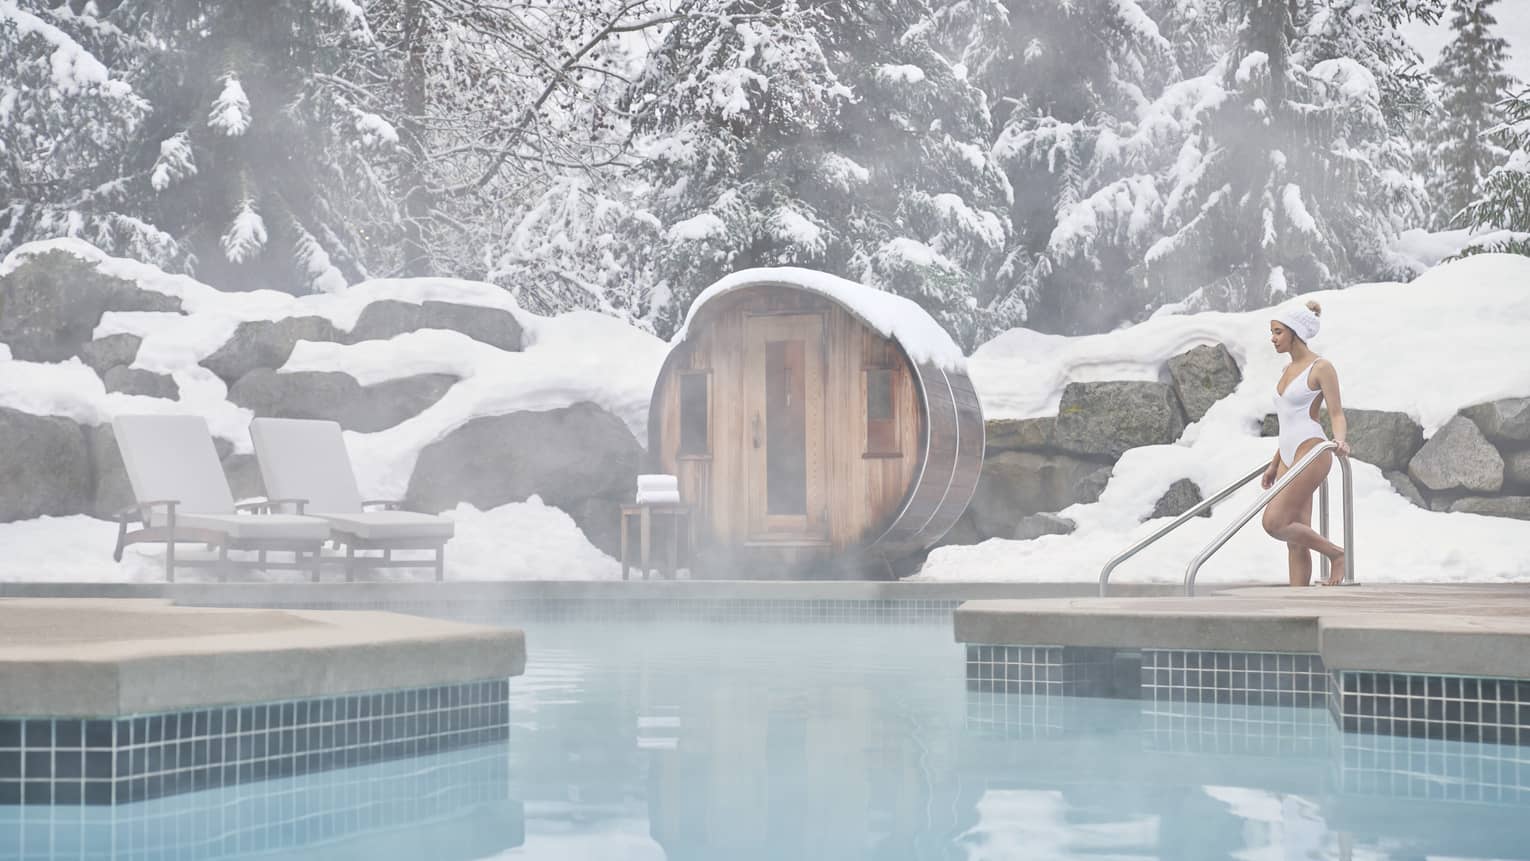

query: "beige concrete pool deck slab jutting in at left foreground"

left=0, top=598, right=526, bottom=717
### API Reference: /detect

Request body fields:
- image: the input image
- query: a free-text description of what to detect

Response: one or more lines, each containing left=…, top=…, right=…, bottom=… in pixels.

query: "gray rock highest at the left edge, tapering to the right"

left=0, top=251, right=181, bottom=362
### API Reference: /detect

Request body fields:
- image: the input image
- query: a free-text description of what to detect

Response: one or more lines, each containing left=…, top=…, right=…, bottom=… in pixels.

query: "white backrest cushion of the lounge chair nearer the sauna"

left=249, top=419, right=370, bottom=512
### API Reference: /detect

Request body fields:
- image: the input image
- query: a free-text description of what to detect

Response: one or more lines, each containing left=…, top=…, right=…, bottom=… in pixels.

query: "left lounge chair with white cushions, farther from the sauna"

left=112, top=416, right=329, bottom=581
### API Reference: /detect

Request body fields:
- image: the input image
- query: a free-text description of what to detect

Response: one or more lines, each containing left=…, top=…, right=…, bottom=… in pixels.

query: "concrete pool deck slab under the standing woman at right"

left=953, top=584, right=1530, bottom=679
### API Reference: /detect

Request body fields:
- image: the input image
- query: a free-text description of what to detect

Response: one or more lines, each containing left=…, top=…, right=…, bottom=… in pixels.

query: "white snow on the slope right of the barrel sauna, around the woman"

left=920, top=249, right=1530, bottom=583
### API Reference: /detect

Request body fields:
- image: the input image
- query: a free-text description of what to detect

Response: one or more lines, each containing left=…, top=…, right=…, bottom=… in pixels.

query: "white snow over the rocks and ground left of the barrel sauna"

left=0, top=240, right=667, bottom=580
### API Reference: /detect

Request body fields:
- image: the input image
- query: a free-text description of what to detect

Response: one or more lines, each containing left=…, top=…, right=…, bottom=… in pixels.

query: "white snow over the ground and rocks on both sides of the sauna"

left=0, top=240, right=1530, bottom=583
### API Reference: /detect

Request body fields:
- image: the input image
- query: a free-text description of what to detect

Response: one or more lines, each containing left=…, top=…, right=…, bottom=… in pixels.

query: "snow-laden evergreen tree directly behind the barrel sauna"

left=635, top=0, right=1017, bottom=344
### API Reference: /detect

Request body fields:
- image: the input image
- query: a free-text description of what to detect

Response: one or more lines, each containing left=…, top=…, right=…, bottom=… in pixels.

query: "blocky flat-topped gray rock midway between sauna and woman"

left=1056, top=382, right=1184, bottom=460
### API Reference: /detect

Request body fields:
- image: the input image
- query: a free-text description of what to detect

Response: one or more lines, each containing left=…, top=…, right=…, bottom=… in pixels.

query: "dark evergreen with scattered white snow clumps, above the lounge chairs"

left=109, top=0, right=382, bottom=292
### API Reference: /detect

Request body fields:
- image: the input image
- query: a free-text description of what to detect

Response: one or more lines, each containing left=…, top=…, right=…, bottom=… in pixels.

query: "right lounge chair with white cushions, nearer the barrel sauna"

left=249, top=419, right=454, bottom=580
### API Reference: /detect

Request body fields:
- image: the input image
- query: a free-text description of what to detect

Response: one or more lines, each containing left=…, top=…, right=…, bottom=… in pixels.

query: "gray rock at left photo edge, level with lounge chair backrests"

left=0, top=407, right=92, bottom=523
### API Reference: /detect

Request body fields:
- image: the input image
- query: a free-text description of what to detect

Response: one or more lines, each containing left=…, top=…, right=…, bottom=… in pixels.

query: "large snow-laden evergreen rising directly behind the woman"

left=1143, top=0, right=1438, bottom=315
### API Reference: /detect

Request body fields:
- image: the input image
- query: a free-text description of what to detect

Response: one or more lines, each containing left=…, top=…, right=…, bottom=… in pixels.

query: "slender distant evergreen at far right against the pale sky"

left=1429, top=0, right=1513, bottom=226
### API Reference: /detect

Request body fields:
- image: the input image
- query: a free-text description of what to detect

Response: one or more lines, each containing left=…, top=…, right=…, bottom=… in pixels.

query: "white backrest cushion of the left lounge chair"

left=112, top=416, right=234, bottom=520
